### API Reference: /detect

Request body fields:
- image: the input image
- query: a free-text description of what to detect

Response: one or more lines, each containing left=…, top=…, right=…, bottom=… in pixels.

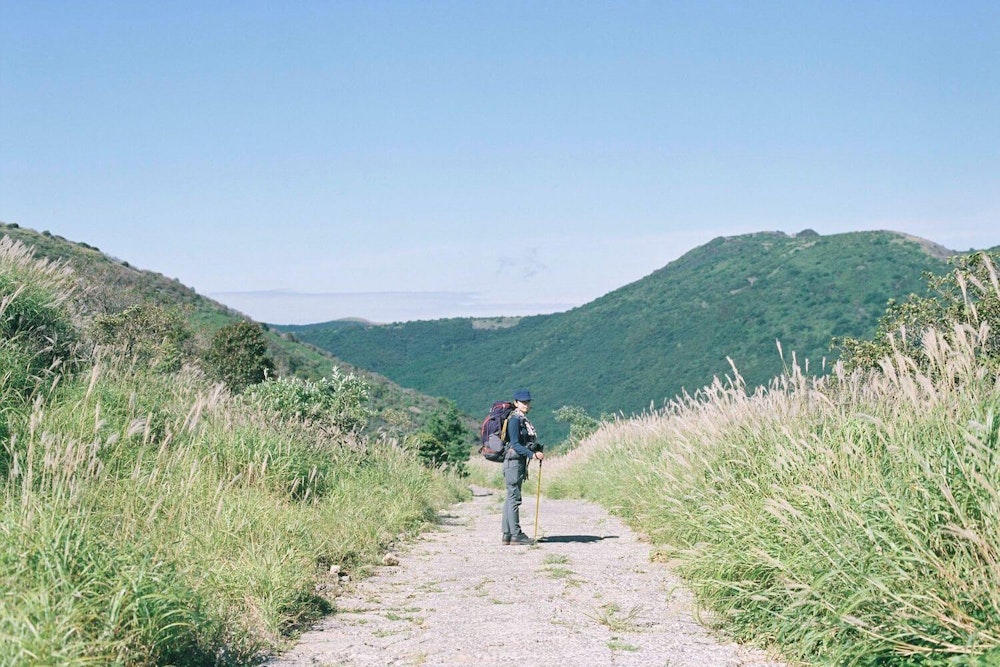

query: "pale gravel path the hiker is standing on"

left=268, top=483, right=782, bottom=667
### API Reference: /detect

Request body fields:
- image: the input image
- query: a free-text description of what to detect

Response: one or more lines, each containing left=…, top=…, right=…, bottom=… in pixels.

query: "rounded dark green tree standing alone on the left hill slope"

left=205, top=320, right=274, bottom=392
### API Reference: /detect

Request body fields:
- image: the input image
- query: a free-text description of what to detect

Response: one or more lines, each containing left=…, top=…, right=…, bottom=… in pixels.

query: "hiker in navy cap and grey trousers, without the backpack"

left=501, top=389, right=545, bottom=545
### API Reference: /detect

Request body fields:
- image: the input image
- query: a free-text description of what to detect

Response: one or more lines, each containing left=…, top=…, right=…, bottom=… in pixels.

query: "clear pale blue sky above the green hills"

left=0, top=0, right=1000, bottom=323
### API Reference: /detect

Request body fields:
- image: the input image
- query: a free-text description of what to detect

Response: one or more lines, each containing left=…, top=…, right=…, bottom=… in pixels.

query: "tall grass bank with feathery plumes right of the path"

left=545, top=249, right=1000, bottom=667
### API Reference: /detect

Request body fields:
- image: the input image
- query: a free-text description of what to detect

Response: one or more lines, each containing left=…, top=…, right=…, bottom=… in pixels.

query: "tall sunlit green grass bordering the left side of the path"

left=0, top=358, right=468, bottom=665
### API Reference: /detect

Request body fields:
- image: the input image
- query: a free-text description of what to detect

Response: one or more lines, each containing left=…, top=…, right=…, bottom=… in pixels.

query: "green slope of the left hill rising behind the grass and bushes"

left=0, top=222, right=443, bottom=431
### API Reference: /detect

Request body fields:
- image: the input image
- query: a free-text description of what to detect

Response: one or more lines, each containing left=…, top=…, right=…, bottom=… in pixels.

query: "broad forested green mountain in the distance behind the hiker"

left=277, top=230, right=955, bottom=443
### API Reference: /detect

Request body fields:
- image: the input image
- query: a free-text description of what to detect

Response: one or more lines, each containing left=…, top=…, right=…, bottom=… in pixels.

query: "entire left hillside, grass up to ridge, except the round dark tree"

left=0, top=227, right=467, bottom=667
